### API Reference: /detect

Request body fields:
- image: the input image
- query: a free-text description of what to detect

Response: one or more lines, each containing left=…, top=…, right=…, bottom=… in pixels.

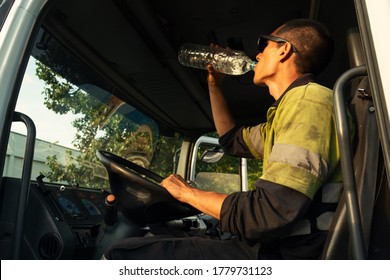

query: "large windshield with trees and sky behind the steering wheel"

left=4, top=30, right=181, bottom=188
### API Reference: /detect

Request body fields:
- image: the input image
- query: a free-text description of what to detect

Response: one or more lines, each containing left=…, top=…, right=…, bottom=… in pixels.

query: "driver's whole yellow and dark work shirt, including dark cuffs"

left=220, top=74, right=341, bottom=256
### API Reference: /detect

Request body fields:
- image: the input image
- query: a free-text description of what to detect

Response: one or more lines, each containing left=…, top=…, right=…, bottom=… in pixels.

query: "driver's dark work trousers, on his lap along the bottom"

left=105, top=231, right=326, bottom=260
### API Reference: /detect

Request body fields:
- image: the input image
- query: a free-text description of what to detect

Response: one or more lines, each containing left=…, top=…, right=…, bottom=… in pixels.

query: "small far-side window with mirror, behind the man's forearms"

left=191, top=137, right=241, bottom=193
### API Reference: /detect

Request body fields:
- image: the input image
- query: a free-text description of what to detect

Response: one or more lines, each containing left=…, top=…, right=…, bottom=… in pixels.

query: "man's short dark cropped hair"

left=276, top=19, right=334, bottom=75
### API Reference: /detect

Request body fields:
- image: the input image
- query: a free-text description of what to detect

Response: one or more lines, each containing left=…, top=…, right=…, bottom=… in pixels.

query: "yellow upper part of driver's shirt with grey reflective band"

left=242, top=82, right=340, bottom=199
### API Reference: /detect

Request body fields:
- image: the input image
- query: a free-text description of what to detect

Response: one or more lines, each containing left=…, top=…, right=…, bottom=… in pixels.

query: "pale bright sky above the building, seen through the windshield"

left=12, top=58, right=76, bottom=148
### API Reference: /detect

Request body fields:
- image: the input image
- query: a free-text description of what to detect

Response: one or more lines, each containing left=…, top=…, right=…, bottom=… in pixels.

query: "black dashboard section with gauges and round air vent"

left=23, top=182, right=108, bottom=259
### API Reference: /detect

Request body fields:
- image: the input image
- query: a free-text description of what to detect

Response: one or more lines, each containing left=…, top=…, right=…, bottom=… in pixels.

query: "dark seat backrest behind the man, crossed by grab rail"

left=322, top=29, right=380, bottom=259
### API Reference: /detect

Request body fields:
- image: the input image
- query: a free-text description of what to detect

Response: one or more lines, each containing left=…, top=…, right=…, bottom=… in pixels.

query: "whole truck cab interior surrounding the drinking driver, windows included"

left=0, top=0, right=390, bottom=260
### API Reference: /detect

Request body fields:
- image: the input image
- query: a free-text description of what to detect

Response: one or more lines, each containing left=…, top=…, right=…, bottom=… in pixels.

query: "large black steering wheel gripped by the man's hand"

left=96, top=151, right=199, bottom=226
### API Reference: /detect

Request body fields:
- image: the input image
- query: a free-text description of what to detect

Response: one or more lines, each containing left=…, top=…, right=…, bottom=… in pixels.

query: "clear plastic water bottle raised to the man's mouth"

left=178, top=43, right=256, bottom=75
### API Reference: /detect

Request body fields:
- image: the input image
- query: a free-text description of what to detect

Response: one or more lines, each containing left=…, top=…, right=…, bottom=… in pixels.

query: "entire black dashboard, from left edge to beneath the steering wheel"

left=0, top=177, right=222, bottom=260
